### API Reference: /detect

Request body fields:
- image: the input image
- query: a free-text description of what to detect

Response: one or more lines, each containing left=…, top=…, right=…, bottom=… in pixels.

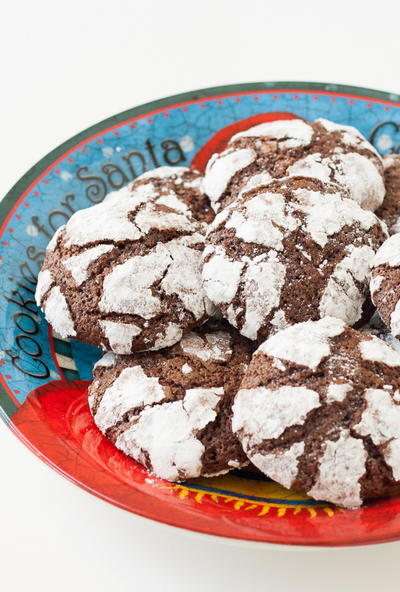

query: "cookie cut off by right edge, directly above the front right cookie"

left=370, top=233, right=400, bottom=337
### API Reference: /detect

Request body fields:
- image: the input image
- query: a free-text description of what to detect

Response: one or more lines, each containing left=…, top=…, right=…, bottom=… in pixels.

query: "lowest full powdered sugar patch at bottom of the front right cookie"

left=308, top=430, right=367, bottom=508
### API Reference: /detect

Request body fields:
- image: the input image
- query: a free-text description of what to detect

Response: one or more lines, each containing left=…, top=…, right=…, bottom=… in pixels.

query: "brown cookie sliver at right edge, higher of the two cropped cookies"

left=376, top=154, right=400, bottom=234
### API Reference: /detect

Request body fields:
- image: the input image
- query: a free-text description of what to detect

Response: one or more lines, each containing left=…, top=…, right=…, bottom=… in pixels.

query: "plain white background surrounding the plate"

left=0, top=0, right=400, bottom=592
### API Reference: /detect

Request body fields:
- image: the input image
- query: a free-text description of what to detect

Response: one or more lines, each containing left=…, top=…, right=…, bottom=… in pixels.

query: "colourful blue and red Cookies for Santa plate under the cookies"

left=0, top=82, right=400, bottom=546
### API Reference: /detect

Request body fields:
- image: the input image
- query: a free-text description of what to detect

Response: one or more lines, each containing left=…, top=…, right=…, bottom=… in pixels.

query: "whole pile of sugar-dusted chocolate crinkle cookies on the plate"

left=36, top=119, right=400, bottom=508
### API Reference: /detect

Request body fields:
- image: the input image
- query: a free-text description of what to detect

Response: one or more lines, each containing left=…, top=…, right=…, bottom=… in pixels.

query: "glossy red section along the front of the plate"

left=7, top=382, right=400, bottom=545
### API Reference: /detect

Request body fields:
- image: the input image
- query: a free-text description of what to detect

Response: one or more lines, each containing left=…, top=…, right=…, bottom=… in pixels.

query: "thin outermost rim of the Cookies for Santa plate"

left=0, top=81, right=400, bottom=550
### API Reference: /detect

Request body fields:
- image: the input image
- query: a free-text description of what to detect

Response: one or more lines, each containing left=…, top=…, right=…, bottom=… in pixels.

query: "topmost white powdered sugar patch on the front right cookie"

left=257, top=317, right=345, bottom=370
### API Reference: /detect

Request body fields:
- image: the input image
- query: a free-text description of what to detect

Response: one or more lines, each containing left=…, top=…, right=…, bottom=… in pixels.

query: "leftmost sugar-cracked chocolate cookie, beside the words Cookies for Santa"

left=36, top=184, right=213, bottom=354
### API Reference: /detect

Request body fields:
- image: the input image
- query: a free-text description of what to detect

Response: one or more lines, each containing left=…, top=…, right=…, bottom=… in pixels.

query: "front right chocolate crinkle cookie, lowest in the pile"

left=233, top=317, right=400, bottom=508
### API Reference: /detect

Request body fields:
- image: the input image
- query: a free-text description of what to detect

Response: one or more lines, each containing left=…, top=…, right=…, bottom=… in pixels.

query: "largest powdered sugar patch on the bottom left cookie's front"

left=116, top=388, right=223, bottom=481
